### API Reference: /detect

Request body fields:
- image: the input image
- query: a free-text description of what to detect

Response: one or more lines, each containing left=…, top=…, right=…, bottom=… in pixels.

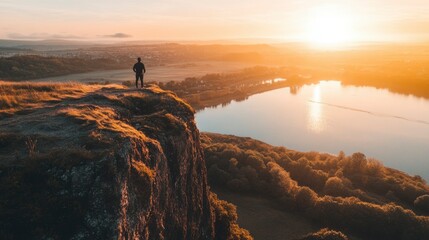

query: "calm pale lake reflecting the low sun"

left=196, top=81, right=429, bottom=180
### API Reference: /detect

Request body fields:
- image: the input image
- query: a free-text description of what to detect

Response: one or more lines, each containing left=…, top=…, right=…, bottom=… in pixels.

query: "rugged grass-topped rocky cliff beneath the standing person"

left=0, top=83, right=215, bottom=239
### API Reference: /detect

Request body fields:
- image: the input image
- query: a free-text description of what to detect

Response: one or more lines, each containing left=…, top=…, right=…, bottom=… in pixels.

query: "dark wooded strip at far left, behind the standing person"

left=0, top=55, right=124, bottom=80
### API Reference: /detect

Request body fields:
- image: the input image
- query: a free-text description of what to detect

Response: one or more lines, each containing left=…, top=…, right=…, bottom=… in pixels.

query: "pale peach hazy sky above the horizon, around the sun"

left=0, top=0, right=429, bottom=40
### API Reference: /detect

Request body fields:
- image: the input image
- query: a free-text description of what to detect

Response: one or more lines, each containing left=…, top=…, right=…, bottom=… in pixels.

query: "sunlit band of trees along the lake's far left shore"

left=157, top=66, right=309, bottom=110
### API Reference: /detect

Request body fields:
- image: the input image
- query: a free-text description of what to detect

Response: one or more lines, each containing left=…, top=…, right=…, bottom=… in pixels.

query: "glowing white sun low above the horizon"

left=305, top=6, right=356, bottom=48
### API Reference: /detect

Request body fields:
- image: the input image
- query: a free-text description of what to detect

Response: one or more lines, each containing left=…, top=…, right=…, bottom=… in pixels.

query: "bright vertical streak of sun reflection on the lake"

left=307, top=85, right=326, bottom=133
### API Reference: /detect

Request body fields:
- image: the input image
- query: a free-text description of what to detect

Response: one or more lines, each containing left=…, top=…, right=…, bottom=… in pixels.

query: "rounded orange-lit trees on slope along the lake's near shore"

left=202, top=134, right=429, bottom=239
